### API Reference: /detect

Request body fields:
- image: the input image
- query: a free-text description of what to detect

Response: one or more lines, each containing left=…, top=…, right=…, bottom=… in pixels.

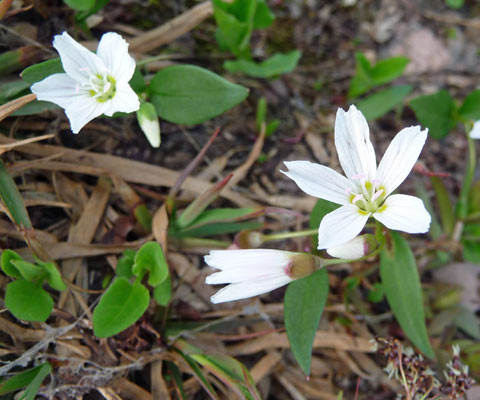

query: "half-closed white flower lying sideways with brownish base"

left=205, top=249, right=321, bottom=303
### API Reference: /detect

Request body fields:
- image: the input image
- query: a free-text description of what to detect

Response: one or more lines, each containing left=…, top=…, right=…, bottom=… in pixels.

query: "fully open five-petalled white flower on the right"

left=282, top=106, right=431, bottom=249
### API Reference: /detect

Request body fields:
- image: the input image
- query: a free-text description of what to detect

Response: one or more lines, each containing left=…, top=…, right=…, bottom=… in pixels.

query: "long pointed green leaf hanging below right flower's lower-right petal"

left=380, top=231, right=435, bottom=358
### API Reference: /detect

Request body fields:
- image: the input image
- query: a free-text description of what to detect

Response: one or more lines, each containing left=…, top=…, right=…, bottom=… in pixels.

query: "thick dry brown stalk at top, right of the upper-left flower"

left=129, top=1, right=213, bottom=53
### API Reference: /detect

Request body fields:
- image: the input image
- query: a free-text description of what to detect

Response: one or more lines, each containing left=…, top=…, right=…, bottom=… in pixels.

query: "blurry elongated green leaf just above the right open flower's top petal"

left=357, top=85, right=412, bottom=121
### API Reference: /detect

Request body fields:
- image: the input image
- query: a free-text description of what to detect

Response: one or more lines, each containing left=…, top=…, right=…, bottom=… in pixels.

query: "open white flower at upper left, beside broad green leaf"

left=31, top=32, right=140, bottom=133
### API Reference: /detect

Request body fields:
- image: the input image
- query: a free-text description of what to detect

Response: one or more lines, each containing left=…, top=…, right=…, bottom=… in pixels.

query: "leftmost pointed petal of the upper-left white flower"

left=30, top=74, right=80, bottom=108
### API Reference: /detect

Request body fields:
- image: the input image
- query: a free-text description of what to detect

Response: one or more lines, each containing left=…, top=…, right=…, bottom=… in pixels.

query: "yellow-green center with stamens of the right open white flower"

left=348, top=174, right=387, bottom=214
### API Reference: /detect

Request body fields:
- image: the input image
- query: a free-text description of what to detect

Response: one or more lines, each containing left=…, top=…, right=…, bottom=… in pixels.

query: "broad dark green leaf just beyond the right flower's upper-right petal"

left=409, top=89, right=456, bottom=139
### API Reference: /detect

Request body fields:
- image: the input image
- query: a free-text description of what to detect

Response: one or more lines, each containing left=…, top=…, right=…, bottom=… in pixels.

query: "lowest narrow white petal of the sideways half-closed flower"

left=210, top=276, right=292, bottom=304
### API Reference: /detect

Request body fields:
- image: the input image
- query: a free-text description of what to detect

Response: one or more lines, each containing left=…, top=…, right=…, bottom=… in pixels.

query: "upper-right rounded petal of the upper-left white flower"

left=97, top=32, right=135, bottom=83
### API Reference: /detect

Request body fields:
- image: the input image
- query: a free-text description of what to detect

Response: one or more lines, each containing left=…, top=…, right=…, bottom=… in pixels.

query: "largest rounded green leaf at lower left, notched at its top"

left=93, top=278, right=150, bottom=337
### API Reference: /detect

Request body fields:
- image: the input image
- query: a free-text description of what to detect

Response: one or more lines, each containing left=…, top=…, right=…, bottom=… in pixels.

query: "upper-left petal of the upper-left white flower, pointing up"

left=53, top=32, right=106, bottom=82
